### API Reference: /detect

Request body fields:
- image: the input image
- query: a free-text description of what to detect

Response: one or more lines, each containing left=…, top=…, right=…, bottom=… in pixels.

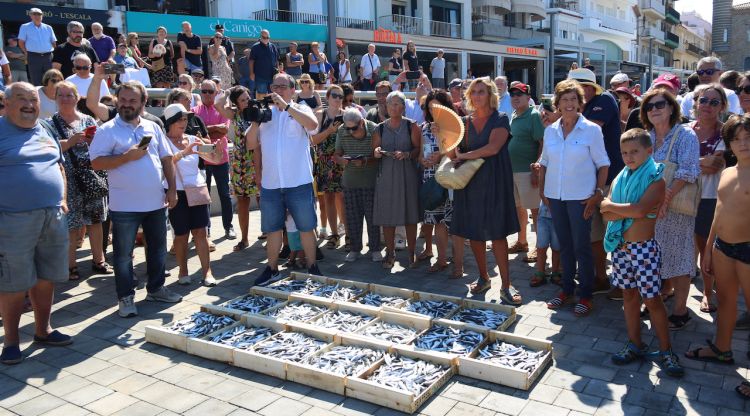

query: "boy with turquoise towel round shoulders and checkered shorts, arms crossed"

left=600, top=129, right=685, bottom=377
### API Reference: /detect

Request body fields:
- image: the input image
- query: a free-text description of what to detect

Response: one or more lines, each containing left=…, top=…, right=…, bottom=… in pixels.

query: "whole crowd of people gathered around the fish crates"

left=0, top=10, right=750, bottom=397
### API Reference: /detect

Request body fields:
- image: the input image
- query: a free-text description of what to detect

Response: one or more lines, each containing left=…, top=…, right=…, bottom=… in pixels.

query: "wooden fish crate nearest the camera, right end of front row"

left=346, top=347, right=456, bottom=414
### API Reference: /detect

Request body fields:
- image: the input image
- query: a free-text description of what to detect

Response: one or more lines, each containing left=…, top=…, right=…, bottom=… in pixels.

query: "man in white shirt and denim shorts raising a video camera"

left=245, top=74, right=321, bottom=285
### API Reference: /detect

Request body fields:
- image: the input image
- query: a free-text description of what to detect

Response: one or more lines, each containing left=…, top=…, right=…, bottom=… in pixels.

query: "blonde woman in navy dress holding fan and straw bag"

left=451, top=78, right=522, bottom=305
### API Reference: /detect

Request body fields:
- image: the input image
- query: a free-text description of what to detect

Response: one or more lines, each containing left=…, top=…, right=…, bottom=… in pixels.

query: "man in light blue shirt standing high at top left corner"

left=18, top=7, right=57, bottom=86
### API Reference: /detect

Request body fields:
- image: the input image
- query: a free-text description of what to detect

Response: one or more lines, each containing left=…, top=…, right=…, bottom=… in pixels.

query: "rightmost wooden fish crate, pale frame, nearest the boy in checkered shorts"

left=458, top=331, right=552, bottom=390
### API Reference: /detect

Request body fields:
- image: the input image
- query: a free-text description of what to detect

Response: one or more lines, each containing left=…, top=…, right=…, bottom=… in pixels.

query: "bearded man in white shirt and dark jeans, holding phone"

left=89, top=82, right=182, bottom=318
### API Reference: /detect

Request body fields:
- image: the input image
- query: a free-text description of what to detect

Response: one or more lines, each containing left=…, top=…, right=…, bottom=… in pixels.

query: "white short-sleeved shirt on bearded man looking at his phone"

left=89, top=115, right=172, bottom=212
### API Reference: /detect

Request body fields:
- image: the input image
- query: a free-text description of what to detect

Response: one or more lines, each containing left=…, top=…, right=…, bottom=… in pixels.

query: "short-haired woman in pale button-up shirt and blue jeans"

left=539, top=80, right=609, bottom=316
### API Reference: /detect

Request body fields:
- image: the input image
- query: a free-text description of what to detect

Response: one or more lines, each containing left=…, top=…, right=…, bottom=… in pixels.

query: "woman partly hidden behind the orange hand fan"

left=417, top=90, right=461, bottom=277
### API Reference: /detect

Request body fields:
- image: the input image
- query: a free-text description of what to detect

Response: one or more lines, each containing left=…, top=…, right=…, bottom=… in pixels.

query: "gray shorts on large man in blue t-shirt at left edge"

left=0, top=207, right=68, bottom=293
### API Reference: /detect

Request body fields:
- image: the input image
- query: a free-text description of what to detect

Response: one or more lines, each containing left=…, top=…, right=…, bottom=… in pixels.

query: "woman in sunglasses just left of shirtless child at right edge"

left=690, top=84, right=727, bottom=313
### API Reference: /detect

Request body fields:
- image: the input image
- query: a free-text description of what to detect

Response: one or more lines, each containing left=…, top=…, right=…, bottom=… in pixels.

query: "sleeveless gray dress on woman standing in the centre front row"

left=373, top=119, right=421, bottom=227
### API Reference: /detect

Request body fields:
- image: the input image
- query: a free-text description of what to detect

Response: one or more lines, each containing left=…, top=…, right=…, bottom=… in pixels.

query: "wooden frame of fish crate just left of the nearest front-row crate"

left=286, top=334, right=390, bottom=396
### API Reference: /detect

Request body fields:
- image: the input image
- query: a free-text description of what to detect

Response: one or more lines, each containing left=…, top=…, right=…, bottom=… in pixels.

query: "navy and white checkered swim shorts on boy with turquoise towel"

left=612, top=239, right=661, bottom=299
